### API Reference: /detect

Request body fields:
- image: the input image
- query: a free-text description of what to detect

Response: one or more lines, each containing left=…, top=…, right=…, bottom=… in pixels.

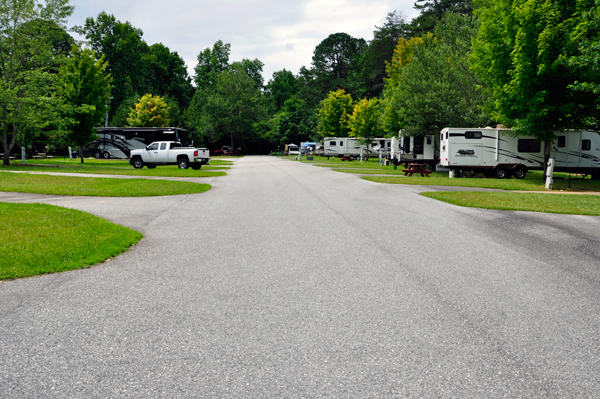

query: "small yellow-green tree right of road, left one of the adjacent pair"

left=317, top=89, right=354, bottom=137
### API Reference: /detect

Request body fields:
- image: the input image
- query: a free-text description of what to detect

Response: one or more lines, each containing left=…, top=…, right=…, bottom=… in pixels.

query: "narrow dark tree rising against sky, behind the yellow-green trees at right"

left=361, top=11, right=407, bottom=97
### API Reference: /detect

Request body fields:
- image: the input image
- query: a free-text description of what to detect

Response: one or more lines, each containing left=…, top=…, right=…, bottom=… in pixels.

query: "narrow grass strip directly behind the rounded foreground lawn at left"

left=0, top=172, right=211, bottom=197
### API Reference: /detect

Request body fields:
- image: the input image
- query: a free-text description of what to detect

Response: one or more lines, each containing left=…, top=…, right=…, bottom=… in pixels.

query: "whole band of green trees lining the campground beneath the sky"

left=0, top=0, right=600, bottom=162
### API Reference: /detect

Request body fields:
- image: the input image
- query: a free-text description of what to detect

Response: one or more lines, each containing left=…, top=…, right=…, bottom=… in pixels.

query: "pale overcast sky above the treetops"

left=68, top=0, right=418, bottom=83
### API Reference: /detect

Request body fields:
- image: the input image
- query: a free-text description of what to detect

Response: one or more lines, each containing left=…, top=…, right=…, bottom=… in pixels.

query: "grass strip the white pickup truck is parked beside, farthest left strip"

left=0, top=158, right=231, bottom=177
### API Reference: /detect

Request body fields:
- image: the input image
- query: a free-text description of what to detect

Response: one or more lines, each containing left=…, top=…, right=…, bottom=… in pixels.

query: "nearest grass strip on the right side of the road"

left=421, top=191, right=600, bottom=216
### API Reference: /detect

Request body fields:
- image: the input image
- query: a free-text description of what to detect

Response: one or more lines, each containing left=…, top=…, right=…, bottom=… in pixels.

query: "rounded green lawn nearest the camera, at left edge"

left=0, top=203, right=143, bottom=280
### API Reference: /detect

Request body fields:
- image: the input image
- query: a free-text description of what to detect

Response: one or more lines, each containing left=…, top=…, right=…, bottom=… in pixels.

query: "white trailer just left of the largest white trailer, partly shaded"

left=390, top=130, right=440, bottom=166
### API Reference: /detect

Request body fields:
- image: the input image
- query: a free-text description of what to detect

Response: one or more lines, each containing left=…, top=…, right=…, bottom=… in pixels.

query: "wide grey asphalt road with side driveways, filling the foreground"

left=0, top=157, right=600, bottom=398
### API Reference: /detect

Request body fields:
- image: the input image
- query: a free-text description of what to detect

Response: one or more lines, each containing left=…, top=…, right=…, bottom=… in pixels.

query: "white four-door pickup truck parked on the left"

left=129, top=141, right=210, bottom=170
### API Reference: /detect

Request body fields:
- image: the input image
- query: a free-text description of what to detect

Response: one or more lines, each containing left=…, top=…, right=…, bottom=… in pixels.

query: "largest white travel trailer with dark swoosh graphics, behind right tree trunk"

left=440, top=128, right=600, bottom=179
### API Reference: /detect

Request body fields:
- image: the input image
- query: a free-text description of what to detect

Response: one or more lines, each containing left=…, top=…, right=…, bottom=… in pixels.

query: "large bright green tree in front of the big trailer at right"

left=471, top=0, right=600, bottom=170
